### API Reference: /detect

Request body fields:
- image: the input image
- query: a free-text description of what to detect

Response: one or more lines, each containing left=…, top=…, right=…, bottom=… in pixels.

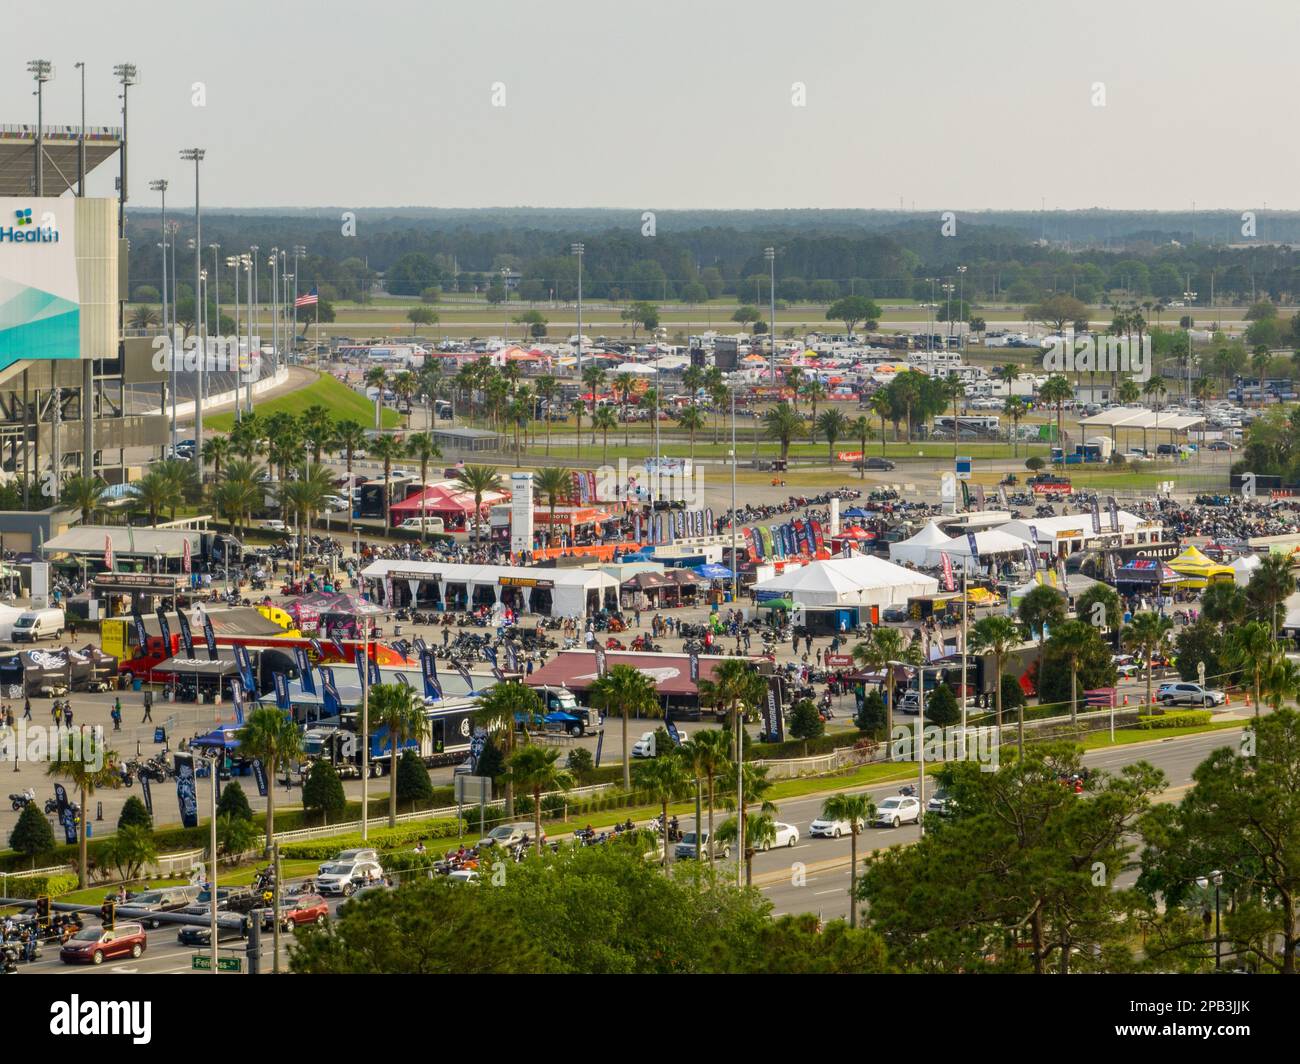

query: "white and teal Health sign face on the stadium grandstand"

left=0, top=196, right=81, bottom=369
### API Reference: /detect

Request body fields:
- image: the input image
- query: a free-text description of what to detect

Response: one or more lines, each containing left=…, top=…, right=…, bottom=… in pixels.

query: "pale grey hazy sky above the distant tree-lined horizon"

left=10, top=0, right=1300, bottom=211
